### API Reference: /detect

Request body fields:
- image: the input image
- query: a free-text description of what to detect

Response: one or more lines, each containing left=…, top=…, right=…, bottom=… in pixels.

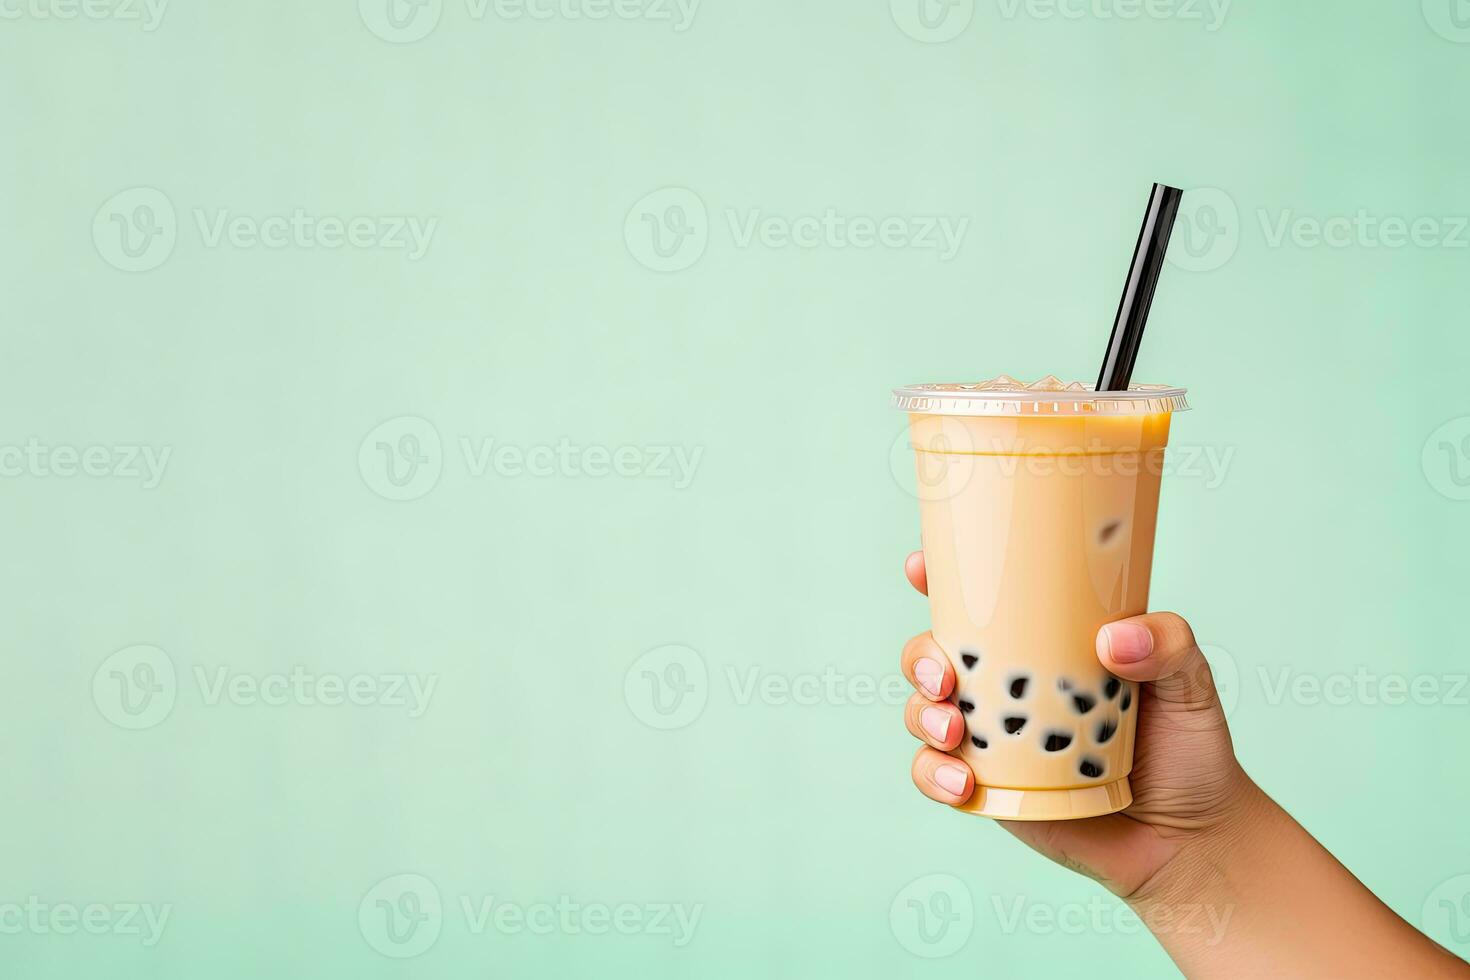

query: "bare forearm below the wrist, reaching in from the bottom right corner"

left=1129, top=785, right=1470, bottom=980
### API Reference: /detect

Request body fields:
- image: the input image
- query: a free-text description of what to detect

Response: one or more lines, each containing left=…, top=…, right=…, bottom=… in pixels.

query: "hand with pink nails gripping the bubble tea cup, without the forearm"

left=903, top=551, right=1261, bottom=898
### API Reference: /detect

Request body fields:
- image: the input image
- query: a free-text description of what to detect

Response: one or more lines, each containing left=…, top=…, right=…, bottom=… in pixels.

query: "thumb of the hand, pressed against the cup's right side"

left=1097, top=613, right=1223, bottom=718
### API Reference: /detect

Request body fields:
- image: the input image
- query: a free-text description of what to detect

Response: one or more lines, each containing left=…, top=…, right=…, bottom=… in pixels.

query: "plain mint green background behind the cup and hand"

left=0, top=0, right=1470, bottom=979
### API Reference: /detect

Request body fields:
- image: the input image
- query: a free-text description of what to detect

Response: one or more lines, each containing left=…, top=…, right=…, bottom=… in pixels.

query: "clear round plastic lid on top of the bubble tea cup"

left=894, top=375, right=1189, bottom=417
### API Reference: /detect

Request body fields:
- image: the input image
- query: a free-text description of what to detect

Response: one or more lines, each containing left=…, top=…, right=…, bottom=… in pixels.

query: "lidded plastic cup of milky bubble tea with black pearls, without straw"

left=894, top=376, right=1188, bottom=820
